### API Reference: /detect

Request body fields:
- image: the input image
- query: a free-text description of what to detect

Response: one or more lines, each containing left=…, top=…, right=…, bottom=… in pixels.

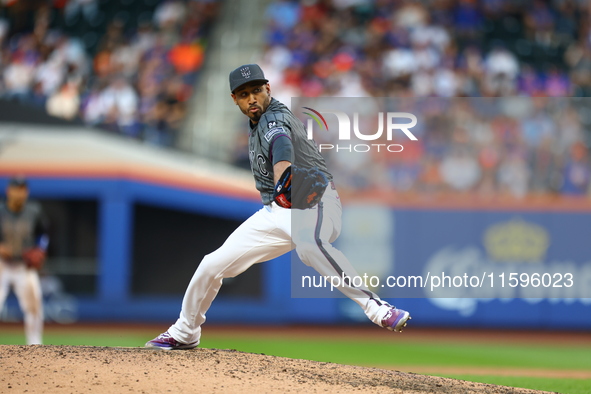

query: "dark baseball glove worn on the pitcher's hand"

left=273, top=166, right=328, bottom=209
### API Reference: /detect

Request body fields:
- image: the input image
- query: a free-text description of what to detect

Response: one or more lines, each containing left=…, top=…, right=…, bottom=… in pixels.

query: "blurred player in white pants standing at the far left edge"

left=0, top=177, right=49, bottom=345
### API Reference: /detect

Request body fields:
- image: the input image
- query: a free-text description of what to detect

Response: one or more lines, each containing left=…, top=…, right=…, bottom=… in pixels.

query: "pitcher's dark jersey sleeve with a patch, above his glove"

left=260, top=113, right=294, bottom=165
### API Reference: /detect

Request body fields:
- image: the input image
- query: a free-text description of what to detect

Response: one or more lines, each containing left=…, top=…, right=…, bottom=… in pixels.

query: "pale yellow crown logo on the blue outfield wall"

left=484, top=219, right=550, bottom=263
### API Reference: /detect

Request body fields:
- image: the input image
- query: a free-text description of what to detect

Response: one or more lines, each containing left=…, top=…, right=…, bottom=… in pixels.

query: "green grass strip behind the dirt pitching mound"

left=0, top=327, right=591, bottom=394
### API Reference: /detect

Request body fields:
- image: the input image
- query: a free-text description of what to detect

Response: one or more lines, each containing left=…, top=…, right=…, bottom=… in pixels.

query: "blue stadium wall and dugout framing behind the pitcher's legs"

left=0, top=177, right=591, bottom=329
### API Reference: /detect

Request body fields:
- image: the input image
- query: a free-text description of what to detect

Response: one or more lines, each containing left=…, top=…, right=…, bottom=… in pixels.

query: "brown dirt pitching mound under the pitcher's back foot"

left=0, top=345, right=556, bottom=394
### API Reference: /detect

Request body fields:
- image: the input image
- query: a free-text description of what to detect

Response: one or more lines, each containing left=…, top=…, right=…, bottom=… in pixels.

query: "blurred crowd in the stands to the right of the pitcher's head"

left=263, top=0, right=591, bottom=198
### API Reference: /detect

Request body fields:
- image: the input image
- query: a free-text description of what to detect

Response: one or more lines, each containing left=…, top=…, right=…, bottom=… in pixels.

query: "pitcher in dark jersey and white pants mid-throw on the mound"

left=146, top=64, right=410, bottom=349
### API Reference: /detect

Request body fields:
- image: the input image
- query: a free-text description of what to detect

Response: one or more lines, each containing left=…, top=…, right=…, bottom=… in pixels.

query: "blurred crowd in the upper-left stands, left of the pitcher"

left=0, top=0, right=218, bottom=146
